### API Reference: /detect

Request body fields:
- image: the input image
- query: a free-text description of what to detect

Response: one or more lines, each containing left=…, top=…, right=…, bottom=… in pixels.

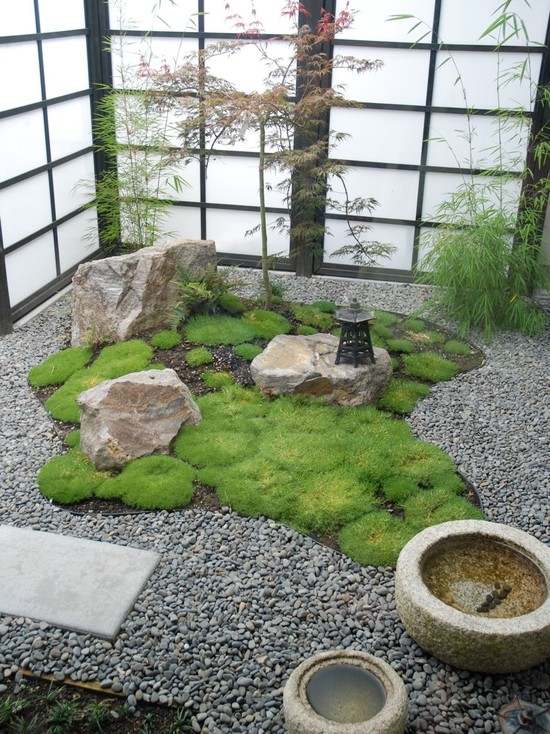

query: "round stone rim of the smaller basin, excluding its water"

left=283, top=650, right=408, bottom=734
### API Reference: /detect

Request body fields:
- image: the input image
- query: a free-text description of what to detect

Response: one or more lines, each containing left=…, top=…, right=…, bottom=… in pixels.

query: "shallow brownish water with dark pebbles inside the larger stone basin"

left=422, top=536, right=547, bottom=617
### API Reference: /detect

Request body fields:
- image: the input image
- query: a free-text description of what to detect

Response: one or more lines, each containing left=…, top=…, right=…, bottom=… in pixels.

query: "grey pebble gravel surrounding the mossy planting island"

left=0, top=272, right=550, bottom=734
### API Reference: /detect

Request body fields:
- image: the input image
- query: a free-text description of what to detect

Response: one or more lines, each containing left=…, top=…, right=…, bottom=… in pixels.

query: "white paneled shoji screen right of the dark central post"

left=324, top=0, right=550, bottom=279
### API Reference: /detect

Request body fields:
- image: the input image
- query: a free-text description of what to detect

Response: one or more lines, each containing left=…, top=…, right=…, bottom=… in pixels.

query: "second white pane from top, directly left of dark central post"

left=207, top=41, right=291, bottom=93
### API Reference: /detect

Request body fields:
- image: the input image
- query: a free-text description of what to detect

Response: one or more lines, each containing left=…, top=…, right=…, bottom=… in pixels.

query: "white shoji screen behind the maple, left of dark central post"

left=110, top=0, right=296, bottom=261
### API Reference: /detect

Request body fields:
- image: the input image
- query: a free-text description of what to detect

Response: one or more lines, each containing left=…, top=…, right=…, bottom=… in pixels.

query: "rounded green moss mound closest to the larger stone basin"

left=339, top=510, right=417, bottom=566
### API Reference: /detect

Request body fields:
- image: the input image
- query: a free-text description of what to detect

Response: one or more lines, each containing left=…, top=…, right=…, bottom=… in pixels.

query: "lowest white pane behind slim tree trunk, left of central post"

left=206, top=209, right=289, bottom=257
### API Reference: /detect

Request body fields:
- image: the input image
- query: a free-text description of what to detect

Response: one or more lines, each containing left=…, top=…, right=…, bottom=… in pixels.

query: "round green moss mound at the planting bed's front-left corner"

left=38, top=449, right=109, bottom=505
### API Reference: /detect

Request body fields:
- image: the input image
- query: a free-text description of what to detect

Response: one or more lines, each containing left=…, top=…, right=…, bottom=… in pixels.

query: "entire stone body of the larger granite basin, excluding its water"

left=395, top=520, right=550, bottom=673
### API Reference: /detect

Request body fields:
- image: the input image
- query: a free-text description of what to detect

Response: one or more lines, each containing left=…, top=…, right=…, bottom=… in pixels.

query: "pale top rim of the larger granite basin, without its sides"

left=397, top=520, right=550, bottom=634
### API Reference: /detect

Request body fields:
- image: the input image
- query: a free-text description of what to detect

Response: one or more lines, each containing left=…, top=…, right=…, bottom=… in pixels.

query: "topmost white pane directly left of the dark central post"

left=204, top=0, right=295, bottom=34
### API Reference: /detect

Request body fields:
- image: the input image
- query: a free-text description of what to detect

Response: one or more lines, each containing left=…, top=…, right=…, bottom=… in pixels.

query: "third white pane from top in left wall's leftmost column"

left=0, top=110, right=46, bottom=181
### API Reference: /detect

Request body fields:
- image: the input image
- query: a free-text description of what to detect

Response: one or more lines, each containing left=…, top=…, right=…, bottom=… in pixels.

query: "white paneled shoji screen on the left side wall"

left=0, top=0, right=98, bottom=317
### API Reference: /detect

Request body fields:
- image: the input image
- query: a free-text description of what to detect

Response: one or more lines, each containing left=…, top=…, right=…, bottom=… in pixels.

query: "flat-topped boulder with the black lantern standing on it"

left=250, top=334, right=392, bottom=405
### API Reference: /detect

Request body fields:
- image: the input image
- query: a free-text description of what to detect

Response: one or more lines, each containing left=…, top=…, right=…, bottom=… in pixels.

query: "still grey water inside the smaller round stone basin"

left=306, top=664, right=386, bottom=724
